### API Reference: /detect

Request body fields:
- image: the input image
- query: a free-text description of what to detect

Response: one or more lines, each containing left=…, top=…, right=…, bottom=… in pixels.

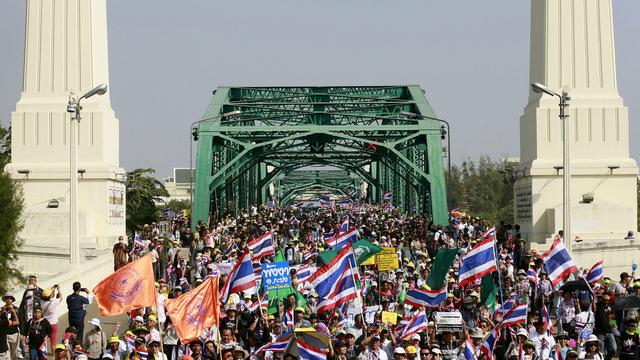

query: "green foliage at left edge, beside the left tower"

left=0, top=170, right=24, bottom=294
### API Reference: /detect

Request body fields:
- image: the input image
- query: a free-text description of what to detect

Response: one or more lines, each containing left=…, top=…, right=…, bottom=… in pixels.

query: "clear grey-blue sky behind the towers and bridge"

left=0, top=0, right=640, bottom=177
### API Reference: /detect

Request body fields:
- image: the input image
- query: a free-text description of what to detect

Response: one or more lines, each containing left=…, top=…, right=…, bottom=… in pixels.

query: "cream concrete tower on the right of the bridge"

left=514, top=0, right=640, bottom=274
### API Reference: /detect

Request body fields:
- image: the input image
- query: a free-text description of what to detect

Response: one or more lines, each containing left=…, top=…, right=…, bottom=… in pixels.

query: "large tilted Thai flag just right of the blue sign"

left=308, top=243, right=358, bottom=313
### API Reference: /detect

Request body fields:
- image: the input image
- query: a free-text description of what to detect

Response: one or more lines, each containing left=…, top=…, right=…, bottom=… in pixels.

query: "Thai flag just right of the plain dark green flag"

left=458, top=236, right=497, bottom=286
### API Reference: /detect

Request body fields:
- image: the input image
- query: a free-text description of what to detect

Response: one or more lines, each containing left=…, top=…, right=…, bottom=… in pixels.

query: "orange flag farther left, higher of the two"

left=93, top=255, right=157, bottom=316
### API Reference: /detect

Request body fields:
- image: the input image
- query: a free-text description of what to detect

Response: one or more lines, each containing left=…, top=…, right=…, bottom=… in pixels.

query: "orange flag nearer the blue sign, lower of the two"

left=165, top=276, right=220, bottom=344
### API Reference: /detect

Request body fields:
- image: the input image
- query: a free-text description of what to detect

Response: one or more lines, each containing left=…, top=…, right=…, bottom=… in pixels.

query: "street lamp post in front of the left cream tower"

left=67, top=84, right=107, bottom=265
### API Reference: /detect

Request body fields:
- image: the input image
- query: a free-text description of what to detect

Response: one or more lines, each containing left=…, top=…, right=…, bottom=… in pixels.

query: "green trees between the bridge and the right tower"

left=447, top=156, right=513, bottom=223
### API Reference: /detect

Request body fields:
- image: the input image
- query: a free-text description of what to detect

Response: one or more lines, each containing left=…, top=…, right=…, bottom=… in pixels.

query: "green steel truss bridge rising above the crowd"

left=192, top=85, right=448, bottom=224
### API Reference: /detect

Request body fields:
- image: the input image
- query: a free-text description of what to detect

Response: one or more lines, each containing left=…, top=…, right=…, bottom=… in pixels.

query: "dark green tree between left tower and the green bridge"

left=126, top=169, right=169, bottom=233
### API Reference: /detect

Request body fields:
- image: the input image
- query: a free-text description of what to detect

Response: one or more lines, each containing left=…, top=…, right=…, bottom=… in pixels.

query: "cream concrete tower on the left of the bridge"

left=6, top=0, right=125, bottom=274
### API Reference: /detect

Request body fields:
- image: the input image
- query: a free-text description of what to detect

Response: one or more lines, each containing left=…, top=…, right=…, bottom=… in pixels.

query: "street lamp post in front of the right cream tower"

left=531, top=82, right=571, bottom=253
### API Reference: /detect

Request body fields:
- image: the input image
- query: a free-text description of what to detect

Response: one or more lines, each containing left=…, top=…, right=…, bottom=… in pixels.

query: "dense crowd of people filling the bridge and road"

left=0, top=204, right=640, bottom=360
